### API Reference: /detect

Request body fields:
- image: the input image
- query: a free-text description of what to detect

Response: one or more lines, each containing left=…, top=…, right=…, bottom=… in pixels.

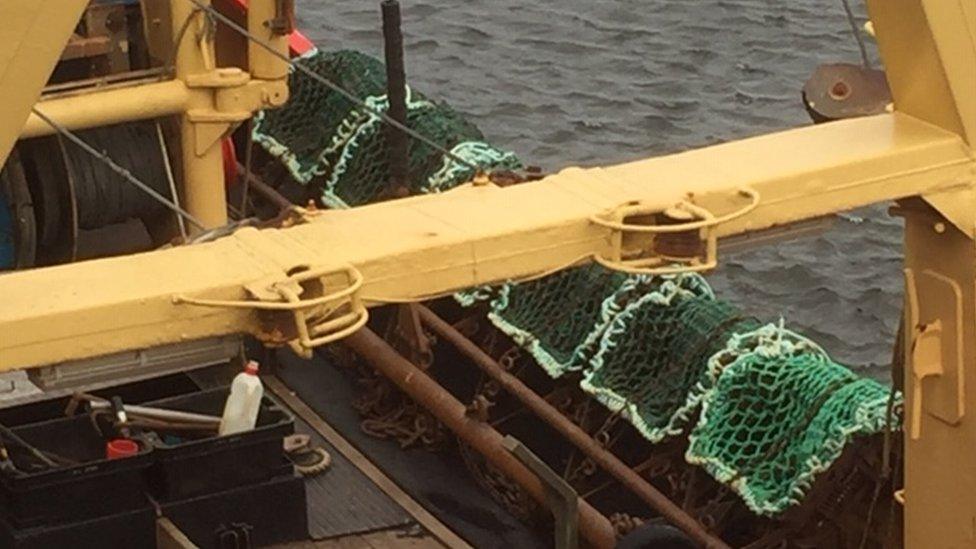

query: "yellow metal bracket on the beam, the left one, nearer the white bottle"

left=173, top=265, right=369, bottom=356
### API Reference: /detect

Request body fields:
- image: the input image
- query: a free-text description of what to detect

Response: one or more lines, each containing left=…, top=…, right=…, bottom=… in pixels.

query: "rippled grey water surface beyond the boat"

left=298, top=0, right=901, bottom=378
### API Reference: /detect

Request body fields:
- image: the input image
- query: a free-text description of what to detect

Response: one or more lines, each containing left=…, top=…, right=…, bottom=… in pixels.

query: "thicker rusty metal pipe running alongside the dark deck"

left=343, top=328, right=616, bottom=549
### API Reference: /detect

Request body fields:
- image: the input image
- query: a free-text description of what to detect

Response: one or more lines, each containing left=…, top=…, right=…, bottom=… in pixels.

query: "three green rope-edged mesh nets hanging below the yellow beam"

left=488, top=272, right=901, bottom=515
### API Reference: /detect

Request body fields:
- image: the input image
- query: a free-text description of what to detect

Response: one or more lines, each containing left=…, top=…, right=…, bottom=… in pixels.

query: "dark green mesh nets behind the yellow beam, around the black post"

left=253, top=51, right=522, bottom=208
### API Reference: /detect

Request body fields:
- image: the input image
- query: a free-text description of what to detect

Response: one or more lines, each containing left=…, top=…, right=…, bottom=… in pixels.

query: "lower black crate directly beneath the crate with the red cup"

left=0, top=507, right=156, bottom=549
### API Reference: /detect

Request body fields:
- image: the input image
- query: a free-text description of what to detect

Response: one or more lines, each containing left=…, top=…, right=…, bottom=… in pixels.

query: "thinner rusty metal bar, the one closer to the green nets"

left=418, top=305, right=729, bottom=549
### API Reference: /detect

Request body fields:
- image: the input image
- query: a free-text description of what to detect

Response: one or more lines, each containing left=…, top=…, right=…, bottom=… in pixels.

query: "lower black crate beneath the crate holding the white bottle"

left=162, top=475, right=308, bottom=549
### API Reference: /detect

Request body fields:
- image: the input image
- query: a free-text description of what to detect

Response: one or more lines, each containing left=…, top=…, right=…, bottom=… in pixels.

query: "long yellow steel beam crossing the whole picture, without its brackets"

left=0, top=114, right=974, bottom=370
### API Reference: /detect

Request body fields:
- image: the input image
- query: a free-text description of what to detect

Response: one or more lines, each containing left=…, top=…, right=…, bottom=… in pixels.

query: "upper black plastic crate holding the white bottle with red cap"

left=145, top=387, right=295, bottom=502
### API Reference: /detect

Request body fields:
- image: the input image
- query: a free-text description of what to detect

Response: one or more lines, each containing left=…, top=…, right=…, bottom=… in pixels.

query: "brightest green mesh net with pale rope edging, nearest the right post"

left=686, top=324, right=897, bottom=515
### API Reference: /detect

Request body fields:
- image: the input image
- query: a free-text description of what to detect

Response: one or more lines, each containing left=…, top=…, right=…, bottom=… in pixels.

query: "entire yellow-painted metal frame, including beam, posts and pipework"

left=0, top=0, right=976, bottom=548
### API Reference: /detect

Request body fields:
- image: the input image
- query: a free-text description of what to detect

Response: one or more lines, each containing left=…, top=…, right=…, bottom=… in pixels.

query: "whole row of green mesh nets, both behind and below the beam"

left=254, top=51, right=901, bottom=516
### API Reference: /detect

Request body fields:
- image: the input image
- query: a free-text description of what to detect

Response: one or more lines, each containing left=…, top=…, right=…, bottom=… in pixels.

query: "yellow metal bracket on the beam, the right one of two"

left=590, top=187, right=759, bottom=275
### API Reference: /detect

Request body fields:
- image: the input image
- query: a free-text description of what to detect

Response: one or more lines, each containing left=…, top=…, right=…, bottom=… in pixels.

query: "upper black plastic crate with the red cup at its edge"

left=0, top=415, right=151, bottom=528
